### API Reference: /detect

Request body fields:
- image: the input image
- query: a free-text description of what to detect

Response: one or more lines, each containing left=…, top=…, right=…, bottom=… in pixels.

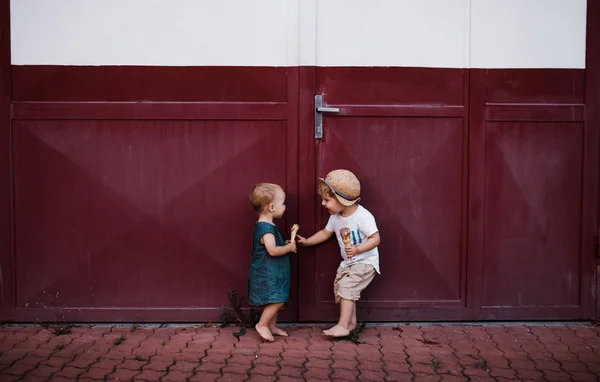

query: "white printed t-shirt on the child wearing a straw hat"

left=325, top=204, right=381, bottom=273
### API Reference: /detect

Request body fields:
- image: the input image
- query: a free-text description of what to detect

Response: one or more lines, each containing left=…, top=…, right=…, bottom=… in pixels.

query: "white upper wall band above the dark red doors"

left=11, top=0, right=586, bottom=68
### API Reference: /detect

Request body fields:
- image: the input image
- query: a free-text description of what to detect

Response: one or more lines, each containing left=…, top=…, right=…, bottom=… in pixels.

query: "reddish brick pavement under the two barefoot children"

left=0, top=323, right=600, bottom=382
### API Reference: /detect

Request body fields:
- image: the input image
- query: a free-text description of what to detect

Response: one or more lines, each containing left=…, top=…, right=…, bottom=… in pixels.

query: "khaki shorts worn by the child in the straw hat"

left=333, top=264, right=376, bottom=303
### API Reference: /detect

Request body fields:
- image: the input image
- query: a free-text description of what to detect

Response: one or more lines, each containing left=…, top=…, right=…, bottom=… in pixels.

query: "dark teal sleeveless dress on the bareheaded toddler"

left=248, top=222, right=290, bottom=305
